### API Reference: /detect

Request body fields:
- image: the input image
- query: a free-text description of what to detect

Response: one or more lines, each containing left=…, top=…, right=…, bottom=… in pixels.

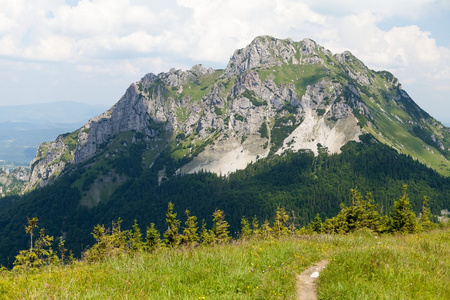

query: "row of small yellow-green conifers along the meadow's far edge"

left=10, top=185, right=442, bottom=271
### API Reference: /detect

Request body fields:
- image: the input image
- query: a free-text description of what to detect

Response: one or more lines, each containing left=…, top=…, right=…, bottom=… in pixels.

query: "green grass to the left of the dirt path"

left=0, top=239, right=320, bottom=299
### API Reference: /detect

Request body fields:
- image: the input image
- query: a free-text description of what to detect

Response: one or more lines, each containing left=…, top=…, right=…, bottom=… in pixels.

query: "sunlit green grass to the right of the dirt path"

left=319, top=230, right=450, bottom=299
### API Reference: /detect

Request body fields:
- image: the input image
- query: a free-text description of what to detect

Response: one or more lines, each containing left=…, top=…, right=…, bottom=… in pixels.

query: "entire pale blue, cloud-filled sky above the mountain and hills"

left=0, top=0, right=450, bottom=123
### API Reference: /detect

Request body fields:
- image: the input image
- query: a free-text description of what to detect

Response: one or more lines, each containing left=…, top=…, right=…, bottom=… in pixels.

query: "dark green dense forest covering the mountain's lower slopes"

left=0, top=135, right=450, bottom=266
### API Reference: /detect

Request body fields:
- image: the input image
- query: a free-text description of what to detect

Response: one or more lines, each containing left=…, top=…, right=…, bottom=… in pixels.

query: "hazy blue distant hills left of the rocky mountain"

left=0, top=102, right=107, bottom=168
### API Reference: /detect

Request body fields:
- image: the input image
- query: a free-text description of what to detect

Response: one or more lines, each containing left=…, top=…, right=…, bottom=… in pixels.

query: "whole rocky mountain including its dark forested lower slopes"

left=0, top=36, right=450, bottom=262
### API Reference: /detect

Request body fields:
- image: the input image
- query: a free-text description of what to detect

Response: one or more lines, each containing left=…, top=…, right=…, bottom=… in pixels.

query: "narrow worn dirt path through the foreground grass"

left=297, top=260, right=328, bottom=300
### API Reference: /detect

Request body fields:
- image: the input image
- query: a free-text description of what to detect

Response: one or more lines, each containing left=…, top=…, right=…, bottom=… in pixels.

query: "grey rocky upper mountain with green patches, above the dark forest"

left=27, top=36, right=450, bottom=189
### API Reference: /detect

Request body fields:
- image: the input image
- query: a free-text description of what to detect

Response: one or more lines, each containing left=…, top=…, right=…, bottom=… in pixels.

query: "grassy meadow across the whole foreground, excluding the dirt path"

left=0, top=228, right=450, bottom=299
